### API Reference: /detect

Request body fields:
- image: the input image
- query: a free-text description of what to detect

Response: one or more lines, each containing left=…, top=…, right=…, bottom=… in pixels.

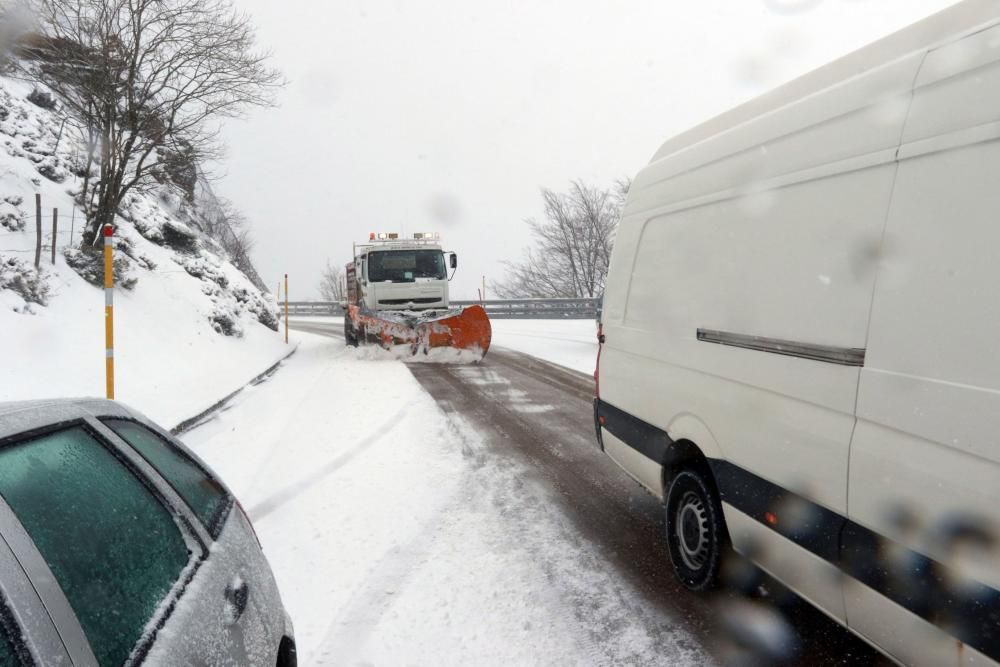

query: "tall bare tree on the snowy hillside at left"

left=18, top=0, right=281, bottom=244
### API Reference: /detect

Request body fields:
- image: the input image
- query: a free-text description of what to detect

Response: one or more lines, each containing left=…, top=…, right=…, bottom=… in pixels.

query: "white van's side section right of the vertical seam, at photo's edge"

left=845, top=28, right=1000, bottom=664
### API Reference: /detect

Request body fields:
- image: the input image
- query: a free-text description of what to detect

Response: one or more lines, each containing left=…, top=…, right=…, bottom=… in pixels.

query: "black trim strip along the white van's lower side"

left=595, top=399, right=1000, bottom=661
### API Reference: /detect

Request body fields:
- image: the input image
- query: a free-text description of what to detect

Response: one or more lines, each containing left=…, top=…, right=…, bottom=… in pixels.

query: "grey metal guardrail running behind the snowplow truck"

left=280, top=299, right=601, bottom=320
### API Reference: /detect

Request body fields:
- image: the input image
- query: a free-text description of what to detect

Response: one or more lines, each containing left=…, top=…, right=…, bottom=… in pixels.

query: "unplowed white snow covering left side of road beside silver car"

left=185, top=329, right=710, bottom=665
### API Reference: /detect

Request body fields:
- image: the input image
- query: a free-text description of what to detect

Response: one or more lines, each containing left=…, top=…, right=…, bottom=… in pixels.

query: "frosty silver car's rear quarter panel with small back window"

left=100, top=418, right=283, bottom=665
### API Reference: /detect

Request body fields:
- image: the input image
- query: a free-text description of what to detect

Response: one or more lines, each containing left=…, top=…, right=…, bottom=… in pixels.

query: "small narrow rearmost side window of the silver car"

left=104, top=419, right=231, bottom=537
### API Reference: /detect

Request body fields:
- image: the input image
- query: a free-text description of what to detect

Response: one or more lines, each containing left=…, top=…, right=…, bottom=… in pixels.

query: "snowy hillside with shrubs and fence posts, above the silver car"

left=0, top=70, right=288, bottom=426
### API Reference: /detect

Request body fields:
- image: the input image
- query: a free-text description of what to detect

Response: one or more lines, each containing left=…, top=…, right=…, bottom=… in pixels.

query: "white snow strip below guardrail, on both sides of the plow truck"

left=289, top=317, right=597, bottom=375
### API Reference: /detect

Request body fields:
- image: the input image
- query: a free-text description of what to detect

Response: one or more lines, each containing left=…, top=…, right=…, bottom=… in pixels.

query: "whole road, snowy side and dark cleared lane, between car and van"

left=184, top=326, right=879, bottom=665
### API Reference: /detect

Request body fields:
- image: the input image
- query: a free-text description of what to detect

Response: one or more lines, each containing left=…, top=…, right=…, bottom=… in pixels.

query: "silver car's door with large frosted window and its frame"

left=0, top=419, right=205, bottom=665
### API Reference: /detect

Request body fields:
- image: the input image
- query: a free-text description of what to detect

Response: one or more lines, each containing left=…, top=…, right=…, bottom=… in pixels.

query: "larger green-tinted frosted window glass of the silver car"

left=0, top=427, right=191, bottom=665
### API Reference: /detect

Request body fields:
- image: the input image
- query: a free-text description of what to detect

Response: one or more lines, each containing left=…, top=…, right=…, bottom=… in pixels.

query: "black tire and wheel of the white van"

left=665, top=468, right=727, bottom=591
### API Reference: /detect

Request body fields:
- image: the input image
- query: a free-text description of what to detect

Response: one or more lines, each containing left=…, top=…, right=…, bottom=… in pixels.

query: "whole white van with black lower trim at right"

left=595, top=0, right=1000, bottom=665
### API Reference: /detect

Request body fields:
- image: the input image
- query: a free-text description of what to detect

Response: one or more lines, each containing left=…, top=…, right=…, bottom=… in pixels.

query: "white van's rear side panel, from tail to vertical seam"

left=601, top=34, right=924, bottom=636
